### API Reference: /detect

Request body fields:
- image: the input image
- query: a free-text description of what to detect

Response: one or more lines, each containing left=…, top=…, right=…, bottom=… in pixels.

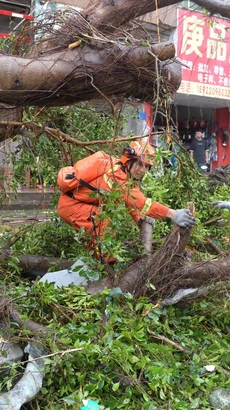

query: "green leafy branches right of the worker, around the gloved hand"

left=143, top=150, right=230, bottom=257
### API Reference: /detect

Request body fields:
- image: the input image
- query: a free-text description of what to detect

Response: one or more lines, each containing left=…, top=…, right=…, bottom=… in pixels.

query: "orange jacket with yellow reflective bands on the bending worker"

left=58, top=164, right=169, bottom=224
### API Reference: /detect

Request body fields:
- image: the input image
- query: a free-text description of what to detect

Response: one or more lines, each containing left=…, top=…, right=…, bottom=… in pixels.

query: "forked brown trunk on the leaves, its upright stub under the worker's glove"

left=87, top=227, right=230, bottom=298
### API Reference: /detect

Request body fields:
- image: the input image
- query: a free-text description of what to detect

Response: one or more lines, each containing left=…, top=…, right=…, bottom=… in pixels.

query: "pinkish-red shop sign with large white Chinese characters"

left=177, top=9, right=230, bottom=99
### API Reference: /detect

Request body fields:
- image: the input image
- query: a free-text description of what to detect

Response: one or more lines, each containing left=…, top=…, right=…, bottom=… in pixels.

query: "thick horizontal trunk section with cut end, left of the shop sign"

left=0, top=42, right=181, bottom=106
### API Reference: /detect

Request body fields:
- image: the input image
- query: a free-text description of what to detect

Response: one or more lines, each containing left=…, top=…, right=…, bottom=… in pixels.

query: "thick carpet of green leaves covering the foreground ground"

left=0, top=282, right=230, bottom=410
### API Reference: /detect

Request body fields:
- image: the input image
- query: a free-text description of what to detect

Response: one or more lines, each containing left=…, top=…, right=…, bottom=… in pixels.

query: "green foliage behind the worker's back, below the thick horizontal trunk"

left=6, top=106, right=116, bottom=190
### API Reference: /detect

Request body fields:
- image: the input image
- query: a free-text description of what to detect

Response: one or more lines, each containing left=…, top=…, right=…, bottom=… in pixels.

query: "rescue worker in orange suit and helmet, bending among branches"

left=57, top=141, right=195, bottom=262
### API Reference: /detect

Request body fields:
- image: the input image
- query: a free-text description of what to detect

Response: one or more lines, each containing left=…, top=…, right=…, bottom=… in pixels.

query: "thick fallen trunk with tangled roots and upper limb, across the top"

left=0, top=0, right=230, bottom=108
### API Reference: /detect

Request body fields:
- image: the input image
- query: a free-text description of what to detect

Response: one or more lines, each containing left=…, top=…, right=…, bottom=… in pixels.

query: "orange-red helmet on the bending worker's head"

left=120, top=141, right=155, bottom=165
